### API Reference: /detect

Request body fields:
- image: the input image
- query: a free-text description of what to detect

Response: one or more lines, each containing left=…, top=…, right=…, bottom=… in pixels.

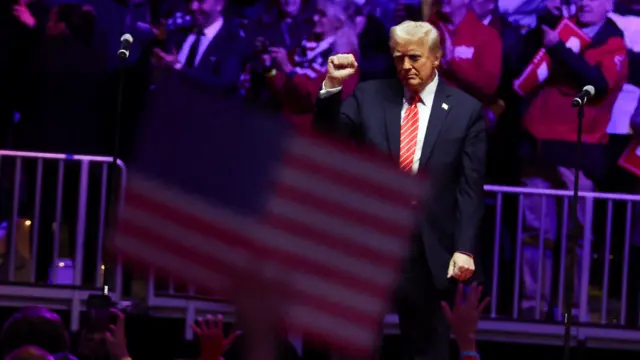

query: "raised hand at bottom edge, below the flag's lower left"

left=191, top=315, right=240, bottom=360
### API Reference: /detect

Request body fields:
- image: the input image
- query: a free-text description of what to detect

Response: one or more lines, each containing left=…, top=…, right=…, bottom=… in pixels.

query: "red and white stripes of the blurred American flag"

left=116, top=131, right=422, bottom=353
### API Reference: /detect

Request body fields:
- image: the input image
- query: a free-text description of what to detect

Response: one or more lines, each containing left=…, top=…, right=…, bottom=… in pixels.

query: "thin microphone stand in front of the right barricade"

left=561, top=98, right=586, bottom=360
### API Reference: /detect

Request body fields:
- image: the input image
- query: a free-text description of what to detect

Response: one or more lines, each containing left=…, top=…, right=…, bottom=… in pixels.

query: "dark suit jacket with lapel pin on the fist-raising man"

left=314, top=79, right=486, bottom=287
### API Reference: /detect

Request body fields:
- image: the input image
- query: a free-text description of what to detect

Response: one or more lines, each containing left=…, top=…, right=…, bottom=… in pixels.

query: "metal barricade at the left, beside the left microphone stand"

left=0, top=150, right=126, bottom=329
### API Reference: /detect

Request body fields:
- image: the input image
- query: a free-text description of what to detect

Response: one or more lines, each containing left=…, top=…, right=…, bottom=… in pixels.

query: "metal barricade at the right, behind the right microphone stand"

left=485, top=185, right=640, bottom=325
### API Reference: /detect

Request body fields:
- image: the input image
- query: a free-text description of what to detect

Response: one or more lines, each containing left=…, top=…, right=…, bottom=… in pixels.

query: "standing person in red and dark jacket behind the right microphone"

left=522, top=0, right=628, bottom=316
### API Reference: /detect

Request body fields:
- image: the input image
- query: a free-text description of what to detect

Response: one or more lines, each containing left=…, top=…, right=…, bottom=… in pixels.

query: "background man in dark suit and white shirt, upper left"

left=154, top=0, right=249, bottom=90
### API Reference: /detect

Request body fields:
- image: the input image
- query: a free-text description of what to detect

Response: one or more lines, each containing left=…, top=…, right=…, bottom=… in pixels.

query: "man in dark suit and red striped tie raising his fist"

left=314, top=21, right=486, bottom=360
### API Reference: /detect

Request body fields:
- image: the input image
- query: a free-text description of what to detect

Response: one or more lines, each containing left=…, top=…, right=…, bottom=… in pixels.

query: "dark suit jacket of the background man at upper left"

left=169, top=18, right=250, bottom=90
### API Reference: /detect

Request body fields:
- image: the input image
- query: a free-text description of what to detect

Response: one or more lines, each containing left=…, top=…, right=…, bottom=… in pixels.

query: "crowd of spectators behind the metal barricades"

left=0, top=0, right=640, bottom=356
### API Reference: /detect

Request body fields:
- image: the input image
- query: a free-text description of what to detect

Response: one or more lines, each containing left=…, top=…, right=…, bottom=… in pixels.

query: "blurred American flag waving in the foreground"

left=115, top=71, right=423, bottom=354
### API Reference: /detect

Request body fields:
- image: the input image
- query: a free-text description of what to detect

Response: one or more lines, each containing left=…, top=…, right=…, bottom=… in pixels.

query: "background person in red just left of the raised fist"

left=267, top=3, right=358, bottom=129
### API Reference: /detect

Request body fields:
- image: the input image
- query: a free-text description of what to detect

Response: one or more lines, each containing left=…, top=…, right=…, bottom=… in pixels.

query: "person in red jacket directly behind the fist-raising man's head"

left=429, top=0, right=502, bottom=105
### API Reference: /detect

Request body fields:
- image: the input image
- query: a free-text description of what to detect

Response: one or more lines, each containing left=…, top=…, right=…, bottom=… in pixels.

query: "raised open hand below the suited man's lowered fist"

left=441, top=283, right=490, bottom=358
